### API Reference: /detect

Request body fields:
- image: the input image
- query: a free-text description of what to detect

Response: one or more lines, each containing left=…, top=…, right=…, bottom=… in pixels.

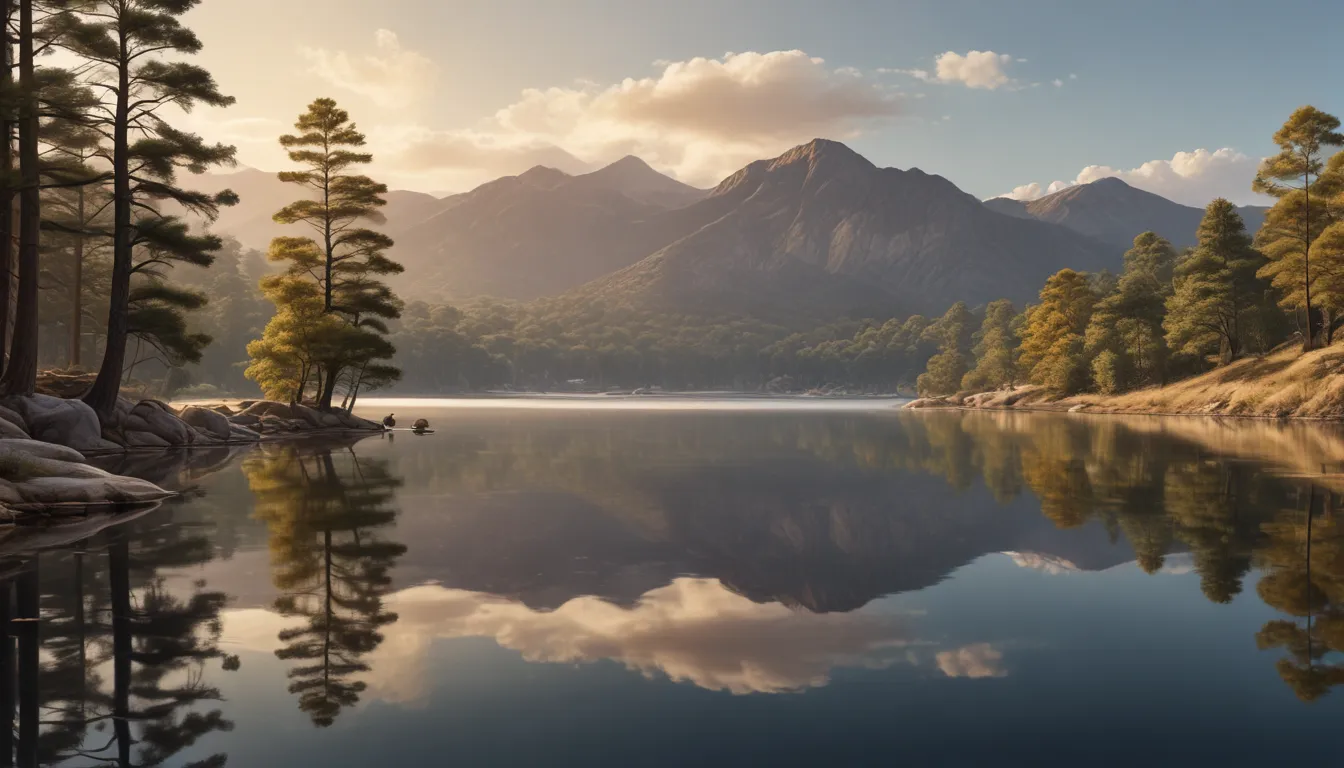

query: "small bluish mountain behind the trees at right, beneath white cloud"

left=984, top=178, right=1269, bottom=252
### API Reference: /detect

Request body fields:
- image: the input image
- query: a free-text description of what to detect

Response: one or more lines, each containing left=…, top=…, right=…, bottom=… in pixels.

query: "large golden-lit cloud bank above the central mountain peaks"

left=381, top=51, right=906, bottom=186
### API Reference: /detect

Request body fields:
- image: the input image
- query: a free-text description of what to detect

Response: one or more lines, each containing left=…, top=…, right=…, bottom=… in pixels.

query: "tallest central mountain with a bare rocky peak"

left=574, top=139, right=1121, bottom=321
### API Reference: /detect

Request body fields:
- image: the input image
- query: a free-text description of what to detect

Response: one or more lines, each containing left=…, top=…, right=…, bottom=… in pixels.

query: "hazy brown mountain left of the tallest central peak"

left=185, top=156, right=707, bottom=300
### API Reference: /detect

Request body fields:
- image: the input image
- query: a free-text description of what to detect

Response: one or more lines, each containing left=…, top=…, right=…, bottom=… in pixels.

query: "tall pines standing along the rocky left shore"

left=0, top=0, right=401, bottom=421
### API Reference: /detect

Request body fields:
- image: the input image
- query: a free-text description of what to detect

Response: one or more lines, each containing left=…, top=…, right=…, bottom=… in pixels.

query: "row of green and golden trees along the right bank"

left=918, top=106, right=1344, bottom=395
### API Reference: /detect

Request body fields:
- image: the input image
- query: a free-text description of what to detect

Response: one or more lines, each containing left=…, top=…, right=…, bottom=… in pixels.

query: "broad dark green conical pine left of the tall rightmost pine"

left=1164, top=198, right=1269, bottom=363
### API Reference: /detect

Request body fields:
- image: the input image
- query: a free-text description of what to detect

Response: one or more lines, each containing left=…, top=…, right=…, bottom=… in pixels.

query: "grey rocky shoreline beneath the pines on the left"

left=0, top=394, right=383, bottom=526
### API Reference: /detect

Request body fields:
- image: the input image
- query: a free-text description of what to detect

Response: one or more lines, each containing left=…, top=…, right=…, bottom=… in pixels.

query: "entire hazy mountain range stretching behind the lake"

left=188, top=139, right=1265, bottom=324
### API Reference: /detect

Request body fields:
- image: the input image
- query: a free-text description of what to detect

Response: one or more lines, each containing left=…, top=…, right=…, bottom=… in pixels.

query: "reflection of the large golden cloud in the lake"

left=226, top=578, right=913, bottom=705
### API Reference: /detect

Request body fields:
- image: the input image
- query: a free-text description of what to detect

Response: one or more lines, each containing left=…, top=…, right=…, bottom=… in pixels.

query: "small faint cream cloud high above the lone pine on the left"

left=298, top=30, right=438, bottom=109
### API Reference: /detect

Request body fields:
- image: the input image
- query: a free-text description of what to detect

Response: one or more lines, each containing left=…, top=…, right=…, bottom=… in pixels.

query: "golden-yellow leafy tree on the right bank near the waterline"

left=1017, top=269, right=1097, bottom=394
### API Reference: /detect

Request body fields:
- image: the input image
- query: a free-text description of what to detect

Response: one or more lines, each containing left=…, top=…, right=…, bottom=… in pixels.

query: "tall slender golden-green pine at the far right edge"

left=1251, top=106, right=1344, bottom=351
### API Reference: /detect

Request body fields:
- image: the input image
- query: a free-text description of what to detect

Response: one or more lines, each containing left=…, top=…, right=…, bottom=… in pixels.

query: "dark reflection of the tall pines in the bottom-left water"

left=0, top=497, right=238, bottom=767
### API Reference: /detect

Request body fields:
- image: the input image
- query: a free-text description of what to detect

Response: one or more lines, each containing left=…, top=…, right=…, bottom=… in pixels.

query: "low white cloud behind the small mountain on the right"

left=1003, top=147, right=1265, bottom=208
